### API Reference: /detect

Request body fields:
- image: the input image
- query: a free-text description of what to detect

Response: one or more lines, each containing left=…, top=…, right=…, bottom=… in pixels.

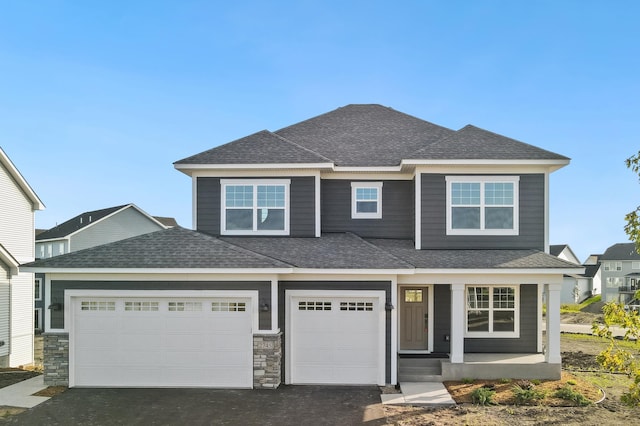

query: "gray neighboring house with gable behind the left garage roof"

left=34, top=204, right=172, bottom=331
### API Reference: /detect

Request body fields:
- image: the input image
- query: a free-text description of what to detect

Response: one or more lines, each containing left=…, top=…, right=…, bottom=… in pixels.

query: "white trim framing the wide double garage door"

left=64, top=290, right=259, bottom=387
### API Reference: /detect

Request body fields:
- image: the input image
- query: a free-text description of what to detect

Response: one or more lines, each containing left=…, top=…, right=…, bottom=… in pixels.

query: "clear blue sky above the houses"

left=0, top=0, right=640, bottom=260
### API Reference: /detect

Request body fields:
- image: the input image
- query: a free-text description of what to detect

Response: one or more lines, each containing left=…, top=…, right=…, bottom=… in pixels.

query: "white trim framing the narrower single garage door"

left=285, top=290, right=386, bottom=385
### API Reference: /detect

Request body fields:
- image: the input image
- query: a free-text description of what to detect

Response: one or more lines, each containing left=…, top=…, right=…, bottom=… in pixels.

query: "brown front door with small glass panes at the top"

left=400, top=287, right=429, bottom=351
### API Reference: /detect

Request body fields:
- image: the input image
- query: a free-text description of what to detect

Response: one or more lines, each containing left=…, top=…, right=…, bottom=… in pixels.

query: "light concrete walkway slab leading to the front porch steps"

left=380, top=382, right=456, bottom=407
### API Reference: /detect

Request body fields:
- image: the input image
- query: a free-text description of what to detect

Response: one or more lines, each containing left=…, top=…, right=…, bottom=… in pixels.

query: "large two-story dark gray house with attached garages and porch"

left=25, top=105, right=583, bottom=388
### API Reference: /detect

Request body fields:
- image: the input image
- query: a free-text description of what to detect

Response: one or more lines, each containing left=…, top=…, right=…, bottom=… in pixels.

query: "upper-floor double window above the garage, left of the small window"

left=220, top=179, right=291, bottom=235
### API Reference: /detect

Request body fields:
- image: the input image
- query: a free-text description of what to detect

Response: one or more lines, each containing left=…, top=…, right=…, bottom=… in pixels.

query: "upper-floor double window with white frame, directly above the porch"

left=446, top=176, right=520, bottom=235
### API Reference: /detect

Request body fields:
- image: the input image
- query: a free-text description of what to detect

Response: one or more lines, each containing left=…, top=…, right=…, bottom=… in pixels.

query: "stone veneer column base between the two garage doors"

left=253, top=333, right=282, bottom=389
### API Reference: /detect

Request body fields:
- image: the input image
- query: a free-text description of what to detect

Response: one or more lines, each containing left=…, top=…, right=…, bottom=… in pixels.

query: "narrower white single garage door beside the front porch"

left=288, top=291, right=385, bottom=385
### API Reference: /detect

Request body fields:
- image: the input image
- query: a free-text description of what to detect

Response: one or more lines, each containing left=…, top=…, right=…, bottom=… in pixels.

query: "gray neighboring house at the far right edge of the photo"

left=599, top=243, right=640, bottom=303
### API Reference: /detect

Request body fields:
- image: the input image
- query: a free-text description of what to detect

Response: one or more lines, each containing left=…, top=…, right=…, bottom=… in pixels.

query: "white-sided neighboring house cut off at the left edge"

left=0, top=148, right=44, bottom=367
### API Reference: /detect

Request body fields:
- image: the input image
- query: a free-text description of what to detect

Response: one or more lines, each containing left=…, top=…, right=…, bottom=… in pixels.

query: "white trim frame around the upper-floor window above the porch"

left=445, top=175, right=520, bottom=235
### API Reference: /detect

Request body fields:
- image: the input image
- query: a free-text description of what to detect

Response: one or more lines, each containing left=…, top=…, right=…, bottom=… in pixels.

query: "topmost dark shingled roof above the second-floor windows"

left=174, top=104, right=569, bottom=170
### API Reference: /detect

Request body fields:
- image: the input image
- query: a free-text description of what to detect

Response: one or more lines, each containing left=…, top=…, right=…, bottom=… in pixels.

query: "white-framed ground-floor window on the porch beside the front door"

left=465, top=285, right=520, bottom=338
